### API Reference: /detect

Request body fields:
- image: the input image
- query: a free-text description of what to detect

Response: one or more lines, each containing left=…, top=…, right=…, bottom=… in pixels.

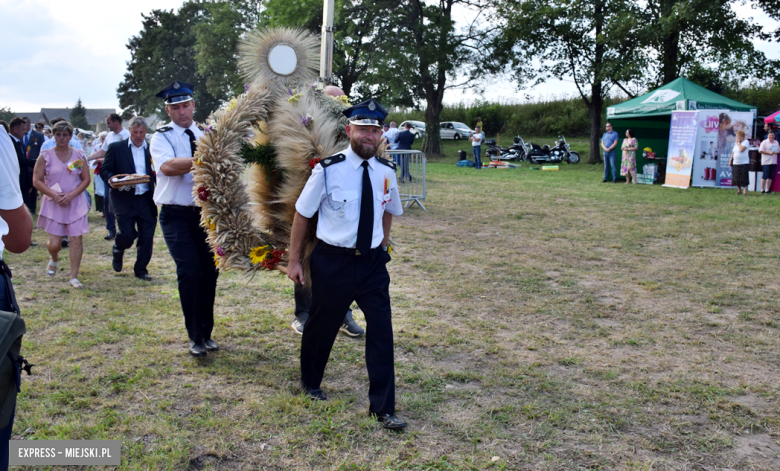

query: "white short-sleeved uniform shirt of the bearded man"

left=295, top=146, right=403, bottom=248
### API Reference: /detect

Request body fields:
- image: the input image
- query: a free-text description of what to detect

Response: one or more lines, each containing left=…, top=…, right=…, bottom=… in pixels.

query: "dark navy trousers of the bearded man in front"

left=301, top=242, right=395, bottom=414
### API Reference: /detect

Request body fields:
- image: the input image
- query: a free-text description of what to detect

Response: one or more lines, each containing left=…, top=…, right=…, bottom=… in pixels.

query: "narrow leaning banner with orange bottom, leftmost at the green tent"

left=664, top=111, right=700, bottom=188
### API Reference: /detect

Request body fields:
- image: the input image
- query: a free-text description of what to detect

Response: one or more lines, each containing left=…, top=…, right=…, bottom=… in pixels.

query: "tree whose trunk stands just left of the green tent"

left=493, top=0, right=645, bottom=163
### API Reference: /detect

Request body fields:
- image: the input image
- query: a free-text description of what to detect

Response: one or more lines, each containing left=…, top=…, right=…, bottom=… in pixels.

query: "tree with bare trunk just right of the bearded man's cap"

left=377, top=0, right=490, bottom=155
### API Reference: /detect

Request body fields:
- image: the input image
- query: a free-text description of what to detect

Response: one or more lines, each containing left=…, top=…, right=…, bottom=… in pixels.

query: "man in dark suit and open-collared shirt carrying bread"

left=100, top=116, right=157, bottom=281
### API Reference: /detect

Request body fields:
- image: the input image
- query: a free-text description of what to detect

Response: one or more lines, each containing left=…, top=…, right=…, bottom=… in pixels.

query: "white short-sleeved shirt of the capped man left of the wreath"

left=149, top=122, right=203, bottom=206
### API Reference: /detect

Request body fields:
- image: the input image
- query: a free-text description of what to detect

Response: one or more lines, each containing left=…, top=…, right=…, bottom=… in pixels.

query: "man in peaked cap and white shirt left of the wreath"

left=151, top=82, right=219, bottom=357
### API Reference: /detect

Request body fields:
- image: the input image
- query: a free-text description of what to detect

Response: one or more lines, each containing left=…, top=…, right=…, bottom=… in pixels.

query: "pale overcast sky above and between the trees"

left=0, top=0, right=780, bottom=112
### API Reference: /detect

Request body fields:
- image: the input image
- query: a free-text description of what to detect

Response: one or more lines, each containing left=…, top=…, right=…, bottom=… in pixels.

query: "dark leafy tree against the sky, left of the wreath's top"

left=117, top=2, right=222, bottom=121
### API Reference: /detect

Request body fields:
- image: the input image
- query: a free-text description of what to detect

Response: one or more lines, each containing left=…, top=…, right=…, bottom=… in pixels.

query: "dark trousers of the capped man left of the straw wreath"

left=160, top=204, right=219, bottom=342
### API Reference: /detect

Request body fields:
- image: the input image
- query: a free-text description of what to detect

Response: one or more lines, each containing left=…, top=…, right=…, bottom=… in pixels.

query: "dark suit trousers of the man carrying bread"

left=114, top=191, right=157, bottom=276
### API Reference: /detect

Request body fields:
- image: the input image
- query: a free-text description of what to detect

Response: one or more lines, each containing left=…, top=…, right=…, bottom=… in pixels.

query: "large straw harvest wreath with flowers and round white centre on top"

left=192, top=28, right=348, bottom=278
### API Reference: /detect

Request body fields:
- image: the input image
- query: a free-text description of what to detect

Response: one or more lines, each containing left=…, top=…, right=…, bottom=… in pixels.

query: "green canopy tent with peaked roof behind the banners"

left=607, top=77, right=755, bottom=181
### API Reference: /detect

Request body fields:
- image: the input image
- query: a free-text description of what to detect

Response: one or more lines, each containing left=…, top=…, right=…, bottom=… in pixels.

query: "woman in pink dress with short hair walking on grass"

left=33, top=121, right=89, bottom=288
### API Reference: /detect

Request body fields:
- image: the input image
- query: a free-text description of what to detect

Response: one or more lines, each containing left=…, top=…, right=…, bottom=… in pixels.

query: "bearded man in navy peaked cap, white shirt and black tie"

left=287, top=99, right=406, bottom=430
